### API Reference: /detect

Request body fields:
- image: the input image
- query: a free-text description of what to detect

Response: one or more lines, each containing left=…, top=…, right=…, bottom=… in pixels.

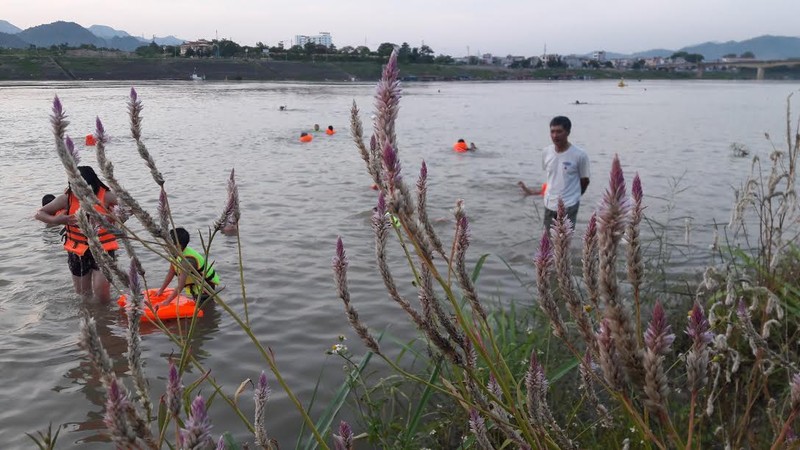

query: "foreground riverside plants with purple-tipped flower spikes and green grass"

left=31, top=53, right=800, bottom=449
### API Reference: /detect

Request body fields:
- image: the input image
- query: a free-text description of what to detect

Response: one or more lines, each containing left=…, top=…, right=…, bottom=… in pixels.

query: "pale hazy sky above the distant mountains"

left=0, top=0, right=800, bottom=57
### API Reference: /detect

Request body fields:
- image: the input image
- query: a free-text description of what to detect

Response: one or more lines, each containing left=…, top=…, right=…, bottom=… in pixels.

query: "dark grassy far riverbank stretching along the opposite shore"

left=0, top=54, right=788, bottom=82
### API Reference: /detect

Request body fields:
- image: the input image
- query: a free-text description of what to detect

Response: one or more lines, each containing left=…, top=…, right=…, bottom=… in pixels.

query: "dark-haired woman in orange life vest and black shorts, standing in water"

left=34, top=166, right=119, bottom=302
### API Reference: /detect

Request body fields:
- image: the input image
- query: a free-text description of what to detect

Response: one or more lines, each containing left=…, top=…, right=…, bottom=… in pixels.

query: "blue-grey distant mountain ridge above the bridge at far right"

left=681, top=35, right=800, bottom=61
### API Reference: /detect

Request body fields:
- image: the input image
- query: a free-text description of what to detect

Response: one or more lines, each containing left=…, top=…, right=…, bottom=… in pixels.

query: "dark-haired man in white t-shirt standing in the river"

left=518, top=116, right=589, bottom=231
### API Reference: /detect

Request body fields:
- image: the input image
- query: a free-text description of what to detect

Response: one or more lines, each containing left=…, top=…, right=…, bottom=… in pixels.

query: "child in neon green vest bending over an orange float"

left=153, top=227, right=219, bottom=306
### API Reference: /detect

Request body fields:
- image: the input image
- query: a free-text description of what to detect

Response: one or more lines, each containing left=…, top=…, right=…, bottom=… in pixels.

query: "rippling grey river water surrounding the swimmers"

left=0, top=81, right=800, bottom=448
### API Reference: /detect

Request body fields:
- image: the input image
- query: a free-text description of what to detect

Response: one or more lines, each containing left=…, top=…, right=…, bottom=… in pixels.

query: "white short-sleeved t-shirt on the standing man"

left=542, top=144, right=589, bottom=211
